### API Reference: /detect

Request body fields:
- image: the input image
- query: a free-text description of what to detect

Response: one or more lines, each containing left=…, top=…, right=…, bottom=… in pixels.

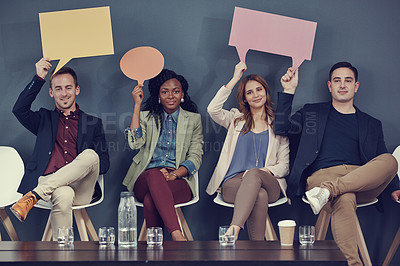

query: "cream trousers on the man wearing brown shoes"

left=33, top=149, right=100, bottom=241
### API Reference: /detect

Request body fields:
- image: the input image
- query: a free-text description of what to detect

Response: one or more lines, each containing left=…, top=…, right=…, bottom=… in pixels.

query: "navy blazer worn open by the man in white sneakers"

left=274, top=92, right=399, bottom=197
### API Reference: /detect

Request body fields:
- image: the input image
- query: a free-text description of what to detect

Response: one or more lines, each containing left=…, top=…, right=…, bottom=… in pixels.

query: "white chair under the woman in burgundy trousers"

left=135, top=172, right=200, bottom=241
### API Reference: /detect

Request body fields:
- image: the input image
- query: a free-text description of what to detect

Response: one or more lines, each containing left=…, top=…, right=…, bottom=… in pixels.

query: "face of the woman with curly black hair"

left=158, top=78, right=184, bottom=114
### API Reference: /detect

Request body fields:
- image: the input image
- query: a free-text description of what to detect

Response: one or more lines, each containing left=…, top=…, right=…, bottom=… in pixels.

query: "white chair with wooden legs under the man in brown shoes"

left=35, top=175, right=104, bottom=241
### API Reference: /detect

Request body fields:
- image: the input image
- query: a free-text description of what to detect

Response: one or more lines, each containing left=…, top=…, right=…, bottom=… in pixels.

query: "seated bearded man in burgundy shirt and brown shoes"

left=11, top=58, right=110, bottom=239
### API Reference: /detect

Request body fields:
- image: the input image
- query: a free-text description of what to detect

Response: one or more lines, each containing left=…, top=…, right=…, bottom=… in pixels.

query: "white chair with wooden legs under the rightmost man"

left=302, top=196, right=378, bottom=266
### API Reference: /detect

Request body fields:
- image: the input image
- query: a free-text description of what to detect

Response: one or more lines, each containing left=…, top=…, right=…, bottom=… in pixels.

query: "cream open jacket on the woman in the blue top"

left=206, top=86, right=289, bottom=196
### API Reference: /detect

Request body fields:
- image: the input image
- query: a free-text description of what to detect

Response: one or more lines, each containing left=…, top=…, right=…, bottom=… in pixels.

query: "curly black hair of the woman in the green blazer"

left=143, top=69, right=198, bottom=128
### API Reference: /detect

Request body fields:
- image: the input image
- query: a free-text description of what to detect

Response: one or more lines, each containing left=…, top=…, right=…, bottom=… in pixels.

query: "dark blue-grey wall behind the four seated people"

left=0, top=0, right=400, bottom=264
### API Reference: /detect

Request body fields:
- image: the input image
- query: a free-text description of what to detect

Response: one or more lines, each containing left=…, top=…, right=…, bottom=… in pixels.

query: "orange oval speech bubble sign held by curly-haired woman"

left=120, top=46, right=164, bottom=85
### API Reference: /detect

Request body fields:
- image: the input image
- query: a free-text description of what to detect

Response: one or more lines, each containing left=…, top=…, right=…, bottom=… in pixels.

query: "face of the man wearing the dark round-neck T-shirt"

left=328, top=67, right=360, bottom=104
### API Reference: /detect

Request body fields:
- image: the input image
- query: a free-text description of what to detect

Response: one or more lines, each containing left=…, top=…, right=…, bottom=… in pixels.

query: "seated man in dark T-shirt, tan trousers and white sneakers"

left=274, top=62, right=400, bottom=265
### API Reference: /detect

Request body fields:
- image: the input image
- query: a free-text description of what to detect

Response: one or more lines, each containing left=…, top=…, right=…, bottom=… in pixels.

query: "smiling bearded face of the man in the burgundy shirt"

left=49, top=74, right=80, bottom=115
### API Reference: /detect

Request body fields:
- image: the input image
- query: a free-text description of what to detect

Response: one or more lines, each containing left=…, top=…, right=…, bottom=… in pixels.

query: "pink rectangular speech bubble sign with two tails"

left=229, top=7, right=317, bottom=70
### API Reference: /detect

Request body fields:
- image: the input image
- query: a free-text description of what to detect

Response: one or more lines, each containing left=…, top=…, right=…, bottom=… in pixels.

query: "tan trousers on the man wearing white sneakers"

left=307, top=153, right=397, bottom=265
